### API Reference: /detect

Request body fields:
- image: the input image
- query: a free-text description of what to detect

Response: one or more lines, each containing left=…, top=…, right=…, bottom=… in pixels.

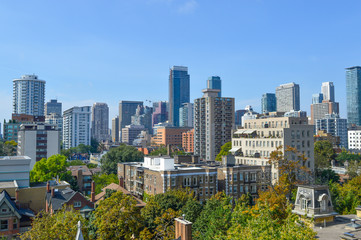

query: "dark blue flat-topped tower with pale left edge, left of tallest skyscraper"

left=119, top=101, right=143, bottom=140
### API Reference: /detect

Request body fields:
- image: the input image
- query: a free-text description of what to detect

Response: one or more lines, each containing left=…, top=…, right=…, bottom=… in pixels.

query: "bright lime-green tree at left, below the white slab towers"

left=30, top=154, right=72, bottom=182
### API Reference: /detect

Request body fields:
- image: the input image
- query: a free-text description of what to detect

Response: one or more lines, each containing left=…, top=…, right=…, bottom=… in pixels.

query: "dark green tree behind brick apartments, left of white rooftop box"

left=100, top=144, right=144, bottom=174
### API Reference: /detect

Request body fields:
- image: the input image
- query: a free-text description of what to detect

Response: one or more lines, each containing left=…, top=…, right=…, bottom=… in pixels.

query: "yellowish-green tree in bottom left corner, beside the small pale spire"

left=20, top=206, right=89, bottom=240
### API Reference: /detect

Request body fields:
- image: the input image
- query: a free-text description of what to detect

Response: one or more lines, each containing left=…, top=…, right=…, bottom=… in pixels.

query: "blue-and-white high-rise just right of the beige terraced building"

left=315, top=114, right=348, bottom=148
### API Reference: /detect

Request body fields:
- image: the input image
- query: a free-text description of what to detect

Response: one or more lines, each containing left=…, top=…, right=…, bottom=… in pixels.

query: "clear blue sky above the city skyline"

left=0, top=0, right=361, bottom=124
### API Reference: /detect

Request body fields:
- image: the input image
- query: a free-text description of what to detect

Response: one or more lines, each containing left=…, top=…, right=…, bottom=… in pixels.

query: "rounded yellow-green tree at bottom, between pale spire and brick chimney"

left=92, top=191, right=143, bottom=240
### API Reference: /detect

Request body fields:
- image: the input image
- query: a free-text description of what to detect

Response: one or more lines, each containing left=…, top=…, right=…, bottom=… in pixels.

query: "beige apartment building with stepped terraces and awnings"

left=231, top=113, right=314, bottom=180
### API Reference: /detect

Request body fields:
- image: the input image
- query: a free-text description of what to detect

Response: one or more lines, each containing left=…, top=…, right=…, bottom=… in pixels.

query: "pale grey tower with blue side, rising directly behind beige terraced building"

left=276, top=83, right=300, bottom=112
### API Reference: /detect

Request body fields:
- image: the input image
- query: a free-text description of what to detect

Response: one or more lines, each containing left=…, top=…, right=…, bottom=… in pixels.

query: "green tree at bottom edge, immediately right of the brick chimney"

left=193, top=192, right=232, bottom=240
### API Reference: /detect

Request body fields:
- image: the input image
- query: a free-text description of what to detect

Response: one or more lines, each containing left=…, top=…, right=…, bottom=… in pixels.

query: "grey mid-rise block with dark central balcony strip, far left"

left=17, top=123, right=60, bottom=169
